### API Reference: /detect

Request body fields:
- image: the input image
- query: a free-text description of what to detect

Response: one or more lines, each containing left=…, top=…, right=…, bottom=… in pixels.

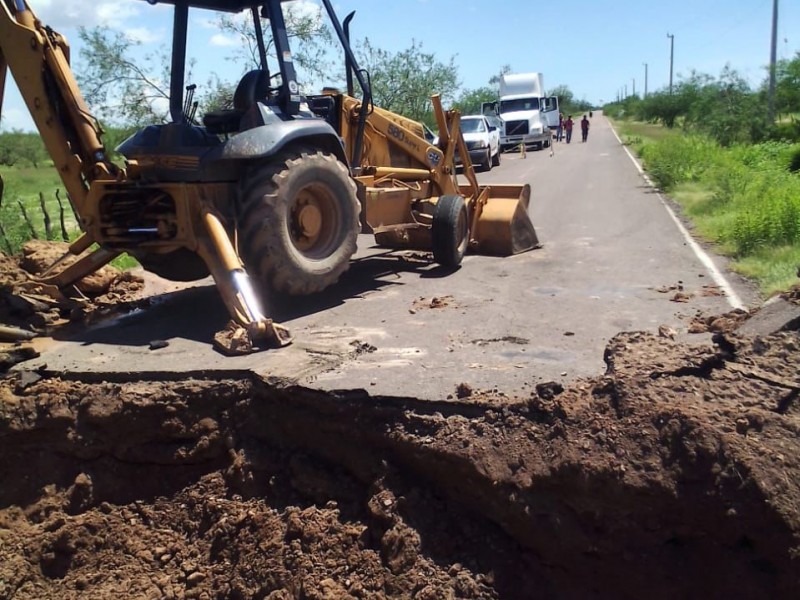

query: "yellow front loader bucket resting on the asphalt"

left=460, top=183, right=539, bottom=256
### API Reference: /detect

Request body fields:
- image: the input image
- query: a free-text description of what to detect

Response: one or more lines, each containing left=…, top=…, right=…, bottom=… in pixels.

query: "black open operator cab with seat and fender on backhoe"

left=118, top=0, right=371, bottom=175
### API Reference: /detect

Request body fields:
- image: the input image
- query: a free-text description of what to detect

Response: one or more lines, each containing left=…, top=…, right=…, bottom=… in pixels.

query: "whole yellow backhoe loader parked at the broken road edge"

left=0, top=0, right=538, bottom=349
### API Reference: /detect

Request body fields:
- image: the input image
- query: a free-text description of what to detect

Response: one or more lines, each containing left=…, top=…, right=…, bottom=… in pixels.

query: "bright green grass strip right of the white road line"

left=614, top=120, right=800, bottom=295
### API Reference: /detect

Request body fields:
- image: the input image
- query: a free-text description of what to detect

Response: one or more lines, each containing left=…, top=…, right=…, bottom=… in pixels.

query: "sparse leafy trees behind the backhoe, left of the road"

left=0, top=4, right=588, bottom=145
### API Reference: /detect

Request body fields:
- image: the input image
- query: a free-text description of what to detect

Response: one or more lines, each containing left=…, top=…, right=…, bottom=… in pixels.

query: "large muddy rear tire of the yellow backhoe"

left=239, top=149, right=360, bottom=295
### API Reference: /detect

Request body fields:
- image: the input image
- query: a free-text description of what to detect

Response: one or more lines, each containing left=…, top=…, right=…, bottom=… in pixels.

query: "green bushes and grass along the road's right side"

left=604, top=54, right=800, bottom=295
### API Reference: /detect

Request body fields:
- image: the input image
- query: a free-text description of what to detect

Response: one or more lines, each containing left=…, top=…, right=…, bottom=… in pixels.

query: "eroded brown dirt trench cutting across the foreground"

left=0, top=332, right=800, bottom=600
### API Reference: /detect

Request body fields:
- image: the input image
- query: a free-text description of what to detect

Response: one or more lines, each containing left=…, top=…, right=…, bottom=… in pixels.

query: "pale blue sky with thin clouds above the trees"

left=0, top=0, right=800, bottom=130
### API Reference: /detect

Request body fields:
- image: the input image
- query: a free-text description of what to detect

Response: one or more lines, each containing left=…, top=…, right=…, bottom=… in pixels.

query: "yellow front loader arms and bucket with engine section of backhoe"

left=340, top=96, right=539, bottom=256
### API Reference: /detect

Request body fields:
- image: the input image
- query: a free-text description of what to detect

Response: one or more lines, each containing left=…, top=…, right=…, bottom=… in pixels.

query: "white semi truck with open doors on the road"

left=482, top=73, right=558, bottom=150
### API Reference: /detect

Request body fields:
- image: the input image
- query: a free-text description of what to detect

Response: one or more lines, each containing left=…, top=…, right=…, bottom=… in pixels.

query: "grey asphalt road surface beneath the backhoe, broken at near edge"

left=25, top=114, right=758, bottom=399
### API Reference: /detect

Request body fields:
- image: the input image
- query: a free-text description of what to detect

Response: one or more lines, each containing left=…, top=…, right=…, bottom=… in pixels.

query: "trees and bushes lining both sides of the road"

left=0, top=5, right=800, bottom=159
